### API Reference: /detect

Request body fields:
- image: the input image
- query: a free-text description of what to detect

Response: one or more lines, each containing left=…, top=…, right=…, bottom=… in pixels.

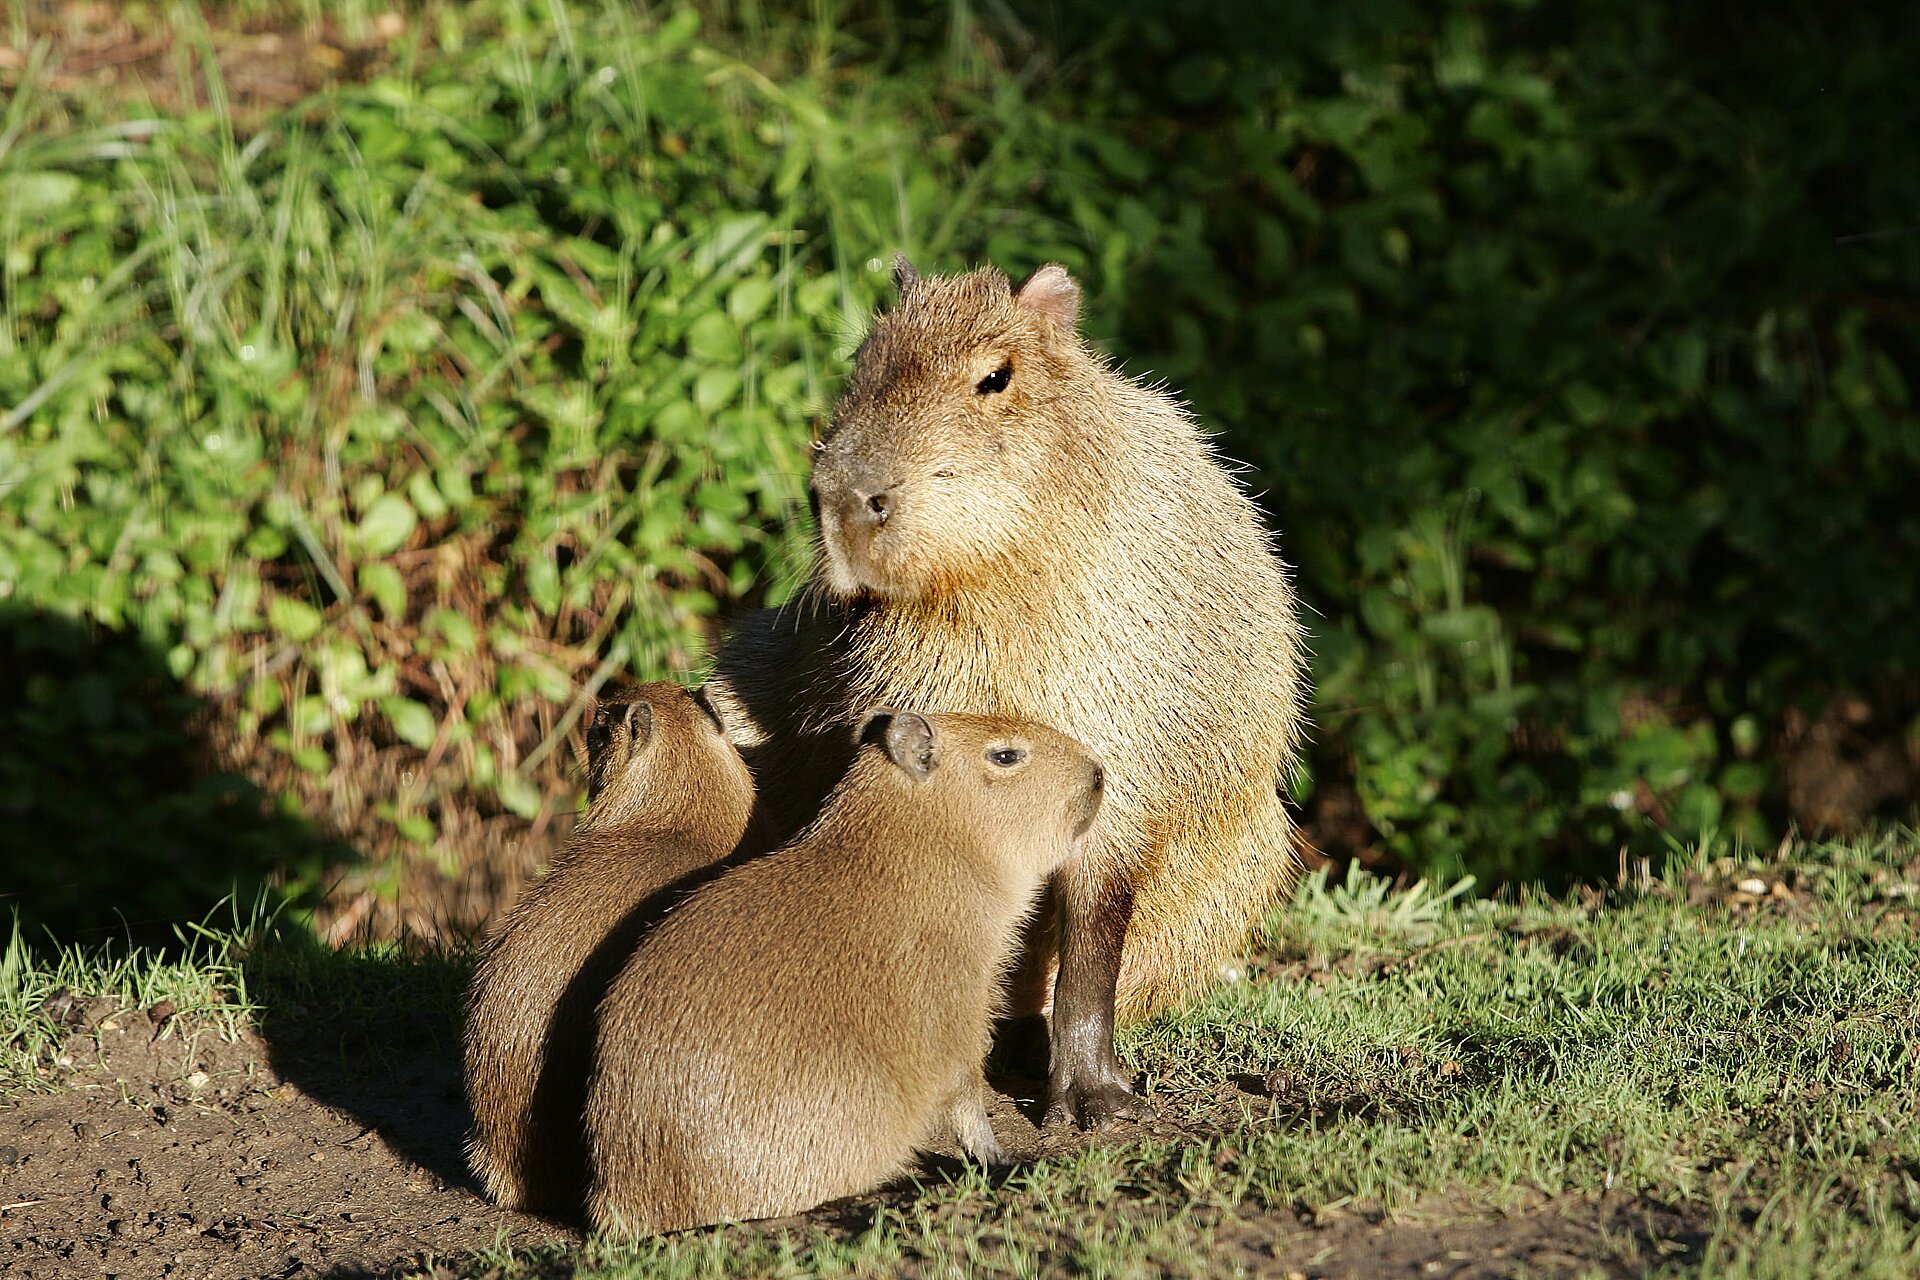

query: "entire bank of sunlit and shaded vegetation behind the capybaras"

left=0, top=0, right=1920, bottom=940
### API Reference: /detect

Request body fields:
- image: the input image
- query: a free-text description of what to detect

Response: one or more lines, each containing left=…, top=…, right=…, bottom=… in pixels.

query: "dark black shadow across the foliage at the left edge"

left=0, top=604, right=351, bottom=950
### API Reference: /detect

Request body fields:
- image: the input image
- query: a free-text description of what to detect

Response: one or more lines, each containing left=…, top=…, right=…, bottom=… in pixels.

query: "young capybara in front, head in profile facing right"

left=586, top=714, right=1102, bottom=1236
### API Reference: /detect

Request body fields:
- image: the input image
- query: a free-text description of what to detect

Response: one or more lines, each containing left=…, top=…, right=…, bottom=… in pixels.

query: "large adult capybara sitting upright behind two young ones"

left=707, top=259, right=1306, bottom=1125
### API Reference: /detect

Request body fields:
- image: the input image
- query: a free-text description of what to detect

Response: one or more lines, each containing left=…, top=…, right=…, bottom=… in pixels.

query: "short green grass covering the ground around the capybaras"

left=15, top=833, right=1920, bottom=1278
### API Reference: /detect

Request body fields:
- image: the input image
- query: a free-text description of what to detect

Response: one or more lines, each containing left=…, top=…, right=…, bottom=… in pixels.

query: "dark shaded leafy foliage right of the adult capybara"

left=990, top=4, right=1920, bottom=877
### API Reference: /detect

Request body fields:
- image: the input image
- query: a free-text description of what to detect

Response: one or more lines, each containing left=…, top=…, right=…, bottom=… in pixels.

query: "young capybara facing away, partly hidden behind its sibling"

left=467, top=683, right=753, bottom=1213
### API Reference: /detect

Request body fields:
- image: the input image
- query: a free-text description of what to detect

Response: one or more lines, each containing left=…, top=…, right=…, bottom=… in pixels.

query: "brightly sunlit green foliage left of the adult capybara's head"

left=0, top=5, right=898, bottom=936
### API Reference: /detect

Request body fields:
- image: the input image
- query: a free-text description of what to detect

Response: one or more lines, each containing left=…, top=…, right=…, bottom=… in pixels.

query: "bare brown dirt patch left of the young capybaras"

left=0, top=1009, right=570, bottom=1280
